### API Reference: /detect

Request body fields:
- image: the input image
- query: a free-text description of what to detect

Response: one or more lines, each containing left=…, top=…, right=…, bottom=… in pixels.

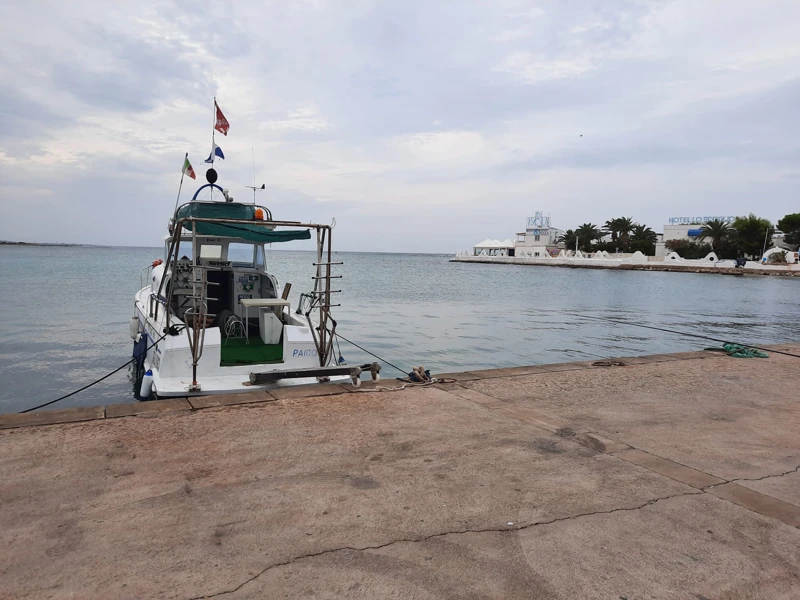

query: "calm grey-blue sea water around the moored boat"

left=0, top=246, right=800, bottom=413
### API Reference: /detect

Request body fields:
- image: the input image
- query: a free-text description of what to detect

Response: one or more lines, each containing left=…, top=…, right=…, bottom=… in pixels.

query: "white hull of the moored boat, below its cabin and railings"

left=134, top=286, right=349, bottom=398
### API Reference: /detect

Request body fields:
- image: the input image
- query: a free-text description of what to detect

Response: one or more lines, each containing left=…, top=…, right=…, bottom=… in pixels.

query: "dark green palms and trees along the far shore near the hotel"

left=558, top=213, right=800, bottom=259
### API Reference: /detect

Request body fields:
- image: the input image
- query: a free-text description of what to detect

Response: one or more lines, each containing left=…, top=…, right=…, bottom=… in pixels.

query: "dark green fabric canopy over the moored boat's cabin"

left=175, top=202, right=311, bottom=243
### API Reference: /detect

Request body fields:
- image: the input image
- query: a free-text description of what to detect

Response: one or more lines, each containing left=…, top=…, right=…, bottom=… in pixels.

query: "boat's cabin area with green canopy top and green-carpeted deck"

left=153, top=202, right=311, bottom=366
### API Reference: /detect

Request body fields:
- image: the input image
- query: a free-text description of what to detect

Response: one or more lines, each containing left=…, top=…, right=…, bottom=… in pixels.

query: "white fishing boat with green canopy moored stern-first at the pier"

left=130, top=103, right=380, bottom=397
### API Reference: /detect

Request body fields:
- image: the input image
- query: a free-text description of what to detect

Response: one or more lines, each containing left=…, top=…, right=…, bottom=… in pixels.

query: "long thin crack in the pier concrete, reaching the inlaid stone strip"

left=189, top=490, right=703, bottom=600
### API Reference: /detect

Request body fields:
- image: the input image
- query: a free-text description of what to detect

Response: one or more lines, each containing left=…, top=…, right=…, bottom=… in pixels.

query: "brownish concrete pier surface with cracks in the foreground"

left=0, top=345, right=800, bottom=600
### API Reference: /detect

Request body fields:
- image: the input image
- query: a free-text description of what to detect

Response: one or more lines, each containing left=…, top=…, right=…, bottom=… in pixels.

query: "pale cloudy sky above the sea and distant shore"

left=0, top=0, right=800, bottom=253
